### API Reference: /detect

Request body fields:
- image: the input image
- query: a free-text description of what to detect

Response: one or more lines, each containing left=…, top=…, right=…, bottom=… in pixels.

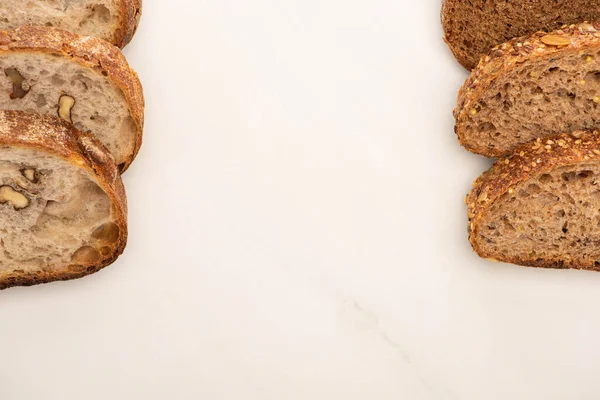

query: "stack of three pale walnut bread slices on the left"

left=0, top=0, right=144, bottom=288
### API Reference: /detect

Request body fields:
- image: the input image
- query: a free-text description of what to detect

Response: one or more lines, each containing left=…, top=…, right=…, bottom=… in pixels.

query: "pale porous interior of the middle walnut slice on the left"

left=0, top=51, right=136, bottom=165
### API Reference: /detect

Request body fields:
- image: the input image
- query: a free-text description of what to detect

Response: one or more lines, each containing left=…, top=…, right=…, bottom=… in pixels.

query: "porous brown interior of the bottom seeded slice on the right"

left=475, top=163, right=600, bottom=267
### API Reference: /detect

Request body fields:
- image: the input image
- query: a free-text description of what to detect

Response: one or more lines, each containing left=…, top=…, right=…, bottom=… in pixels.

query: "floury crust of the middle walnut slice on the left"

left=0, top=25, right=145, bottom=173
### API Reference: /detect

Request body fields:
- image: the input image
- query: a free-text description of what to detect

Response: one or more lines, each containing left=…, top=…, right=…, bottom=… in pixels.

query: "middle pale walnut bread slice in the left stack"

left=0, top=27, right=144, bottom=172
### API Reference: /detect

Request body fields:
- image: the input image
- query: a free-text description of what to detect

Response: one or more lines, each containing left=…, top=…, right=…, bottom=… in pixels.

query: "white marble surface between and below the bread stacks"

left=0, top=0, right=600, bottom=400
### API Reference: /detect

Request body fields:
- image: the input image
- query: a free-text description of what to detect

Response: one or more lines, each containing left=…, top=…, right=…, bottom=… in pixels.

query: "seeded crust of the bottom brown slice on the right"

left=466, top=131, right=600, bottom=271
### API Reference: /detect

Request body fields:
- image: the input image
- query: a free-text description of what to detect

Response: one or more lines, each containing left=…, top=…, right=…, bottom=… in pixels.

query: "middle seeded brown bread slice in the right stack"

left=454, top=23, right=600, bottom=157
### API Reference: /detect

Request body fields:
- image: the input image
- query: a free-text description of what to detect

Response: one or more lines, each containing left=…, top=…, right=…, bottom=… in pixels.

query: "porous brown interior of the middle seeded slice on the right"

left=463, top=50, right=600, bottom=154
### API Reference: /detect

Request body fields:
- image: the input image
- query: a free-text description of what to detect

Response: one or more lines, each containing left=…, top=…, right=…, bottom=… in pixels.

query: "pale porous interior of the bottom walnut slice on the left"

left=0, top=147, right=116, bottom=276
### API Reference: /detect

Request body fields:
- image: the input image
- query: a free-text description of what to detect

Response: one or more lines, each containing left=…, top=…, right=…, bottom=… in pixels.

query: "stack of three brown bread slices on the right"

left=442, top=0, right=600, bottom=270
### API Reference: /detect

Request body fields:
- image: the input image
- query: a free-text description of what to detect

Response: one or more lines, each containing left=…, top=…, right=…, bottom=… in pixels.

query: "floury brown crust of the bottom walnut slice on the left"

left=0, top=111, right=127, bottom=290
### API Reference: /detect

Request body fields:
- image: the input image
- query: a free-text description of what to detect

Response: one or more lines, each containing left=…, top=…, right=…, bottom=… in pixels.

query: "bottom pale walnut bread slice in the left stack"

left=0, top=111, right=127, bottom=289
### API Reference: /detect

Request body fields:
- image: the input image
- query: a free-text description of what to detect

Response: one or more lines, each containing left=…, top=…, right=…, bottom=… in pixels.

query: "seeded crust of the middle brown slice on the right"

left=454, top=22, right=600, bottom=157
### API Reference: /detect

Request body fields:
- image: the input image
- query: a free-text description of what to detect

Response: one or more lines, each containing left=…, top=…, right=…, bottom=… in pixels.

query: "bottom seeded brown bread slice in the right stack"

left=467, top=131, right=600, bottom=271
